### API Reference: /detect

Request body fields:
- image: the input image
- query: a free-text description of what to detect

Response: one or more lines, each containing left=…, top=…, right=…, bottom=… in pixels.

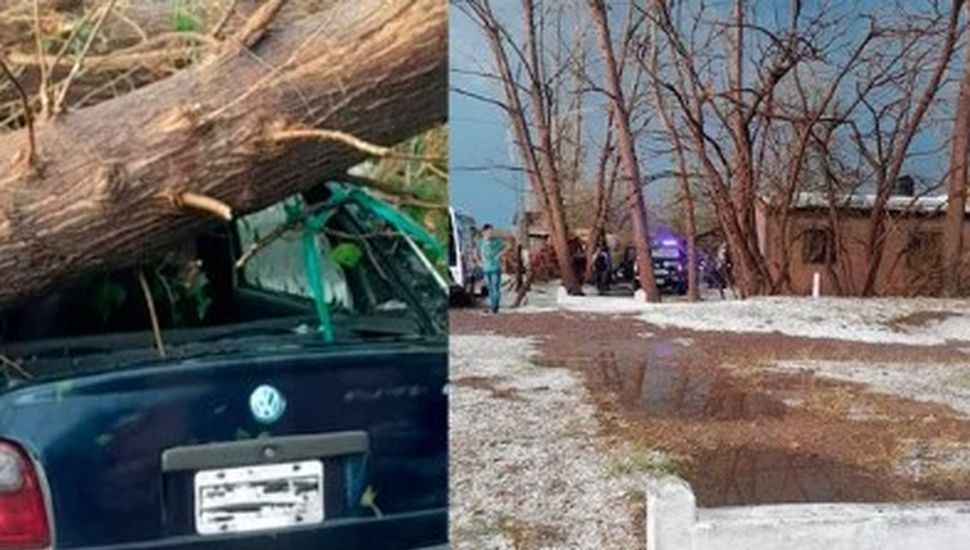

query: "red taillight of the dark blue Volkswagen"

left=0, top=441, right=51, bottom=550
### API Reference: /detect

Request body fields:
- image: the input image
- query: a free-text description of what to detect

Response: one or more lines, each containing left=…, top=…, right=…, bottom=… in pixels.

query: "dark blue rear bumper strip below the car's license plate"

left=65, top=509, right=448, bottom=550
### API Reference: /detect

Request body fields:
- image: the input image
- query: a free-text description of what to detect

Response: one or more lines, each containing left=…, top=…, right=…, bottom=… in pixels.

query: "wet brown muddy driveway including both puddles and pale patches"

left=451, top=310, right=970, bottom=506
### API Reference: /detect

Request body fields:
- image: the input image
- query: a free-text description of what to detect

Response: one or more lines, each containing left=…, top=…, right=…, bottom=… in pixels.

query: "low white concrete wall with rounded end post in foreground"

left=646, top=477, right=970, bottom=550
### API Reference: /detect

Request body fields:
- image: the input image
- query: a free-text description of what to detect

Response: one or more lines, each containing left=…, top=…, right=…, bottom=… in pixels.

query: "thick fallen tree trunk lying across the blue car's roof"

left=0, top=0, right=447, bottom=307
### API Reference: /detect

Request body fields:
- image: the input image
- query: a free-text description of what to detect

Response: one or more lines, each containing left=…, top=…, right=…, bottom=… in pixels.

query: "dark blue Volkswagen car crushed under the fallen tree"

left=0, top=186, right=448, bottom=550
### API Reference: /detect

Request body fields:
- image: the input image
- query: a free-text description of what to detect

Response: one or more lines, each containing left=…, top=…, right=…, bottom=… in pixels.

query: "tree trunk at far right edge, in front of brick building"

left=943, top=5, right=970, bottom=297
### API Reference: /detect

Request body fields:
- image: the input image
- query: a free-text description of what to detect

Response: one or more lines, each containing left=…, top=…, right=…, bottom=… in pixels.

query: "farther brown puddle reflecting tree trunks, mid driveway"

left=596, top=354, right=788, bottom=420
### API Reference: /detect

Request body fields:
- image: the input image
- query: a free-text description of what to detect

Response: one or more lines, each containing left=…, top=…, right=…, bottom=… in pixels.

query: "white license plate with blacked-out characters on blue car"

left=194, top=460, right=323, bottom=535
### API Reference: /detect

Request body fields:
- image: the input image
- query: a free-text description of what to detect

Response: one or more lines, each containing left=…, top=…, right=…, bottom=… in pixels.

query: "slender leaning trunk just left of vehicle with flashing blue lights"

left=589, top=0, right=660, bottom=302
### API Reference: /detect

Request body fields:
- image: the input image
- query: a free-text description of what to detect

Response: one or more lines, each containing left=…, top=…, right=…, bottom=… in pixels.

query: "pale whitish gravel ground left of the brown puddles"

left=450, top=334, right=643, bottom=550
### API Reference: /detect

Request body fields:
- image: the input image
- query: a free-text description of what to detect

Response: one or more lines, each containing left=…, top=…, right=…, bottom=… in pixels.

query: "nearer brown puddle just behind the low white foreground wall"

left=688, top=446, right=905, bottom=506
